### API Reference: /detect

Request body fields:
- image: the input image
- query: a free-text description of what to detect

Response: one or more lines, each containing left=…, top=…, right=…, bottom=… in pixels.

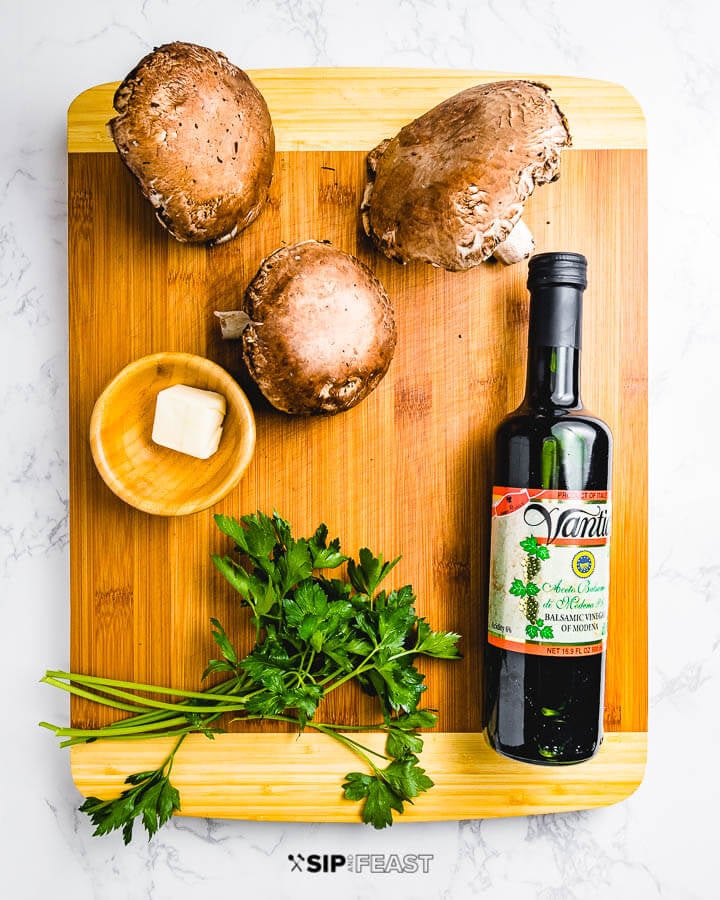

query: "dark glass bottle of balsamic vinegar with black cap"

left=485, top=253, right=612, bottom=765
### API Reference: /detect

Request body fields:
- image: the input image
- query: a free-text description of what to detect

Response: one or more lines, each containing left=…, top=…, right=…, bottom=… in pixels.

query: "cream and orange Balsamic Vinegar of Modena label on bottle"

left=488, top=487, right=610, bottom=656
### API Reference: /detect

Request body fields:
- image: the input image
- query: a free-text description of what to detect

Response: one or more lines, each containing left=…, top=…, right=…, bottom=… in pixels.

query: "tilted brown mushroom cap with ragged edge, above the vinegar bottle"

left=362, top=81, right=571, bottom=271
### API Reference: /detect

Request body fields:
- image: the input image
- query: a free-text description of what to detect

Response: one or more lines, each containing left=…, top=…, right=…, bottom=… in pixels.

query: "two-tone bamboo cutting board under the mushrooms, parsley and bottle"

left=68, top=69, right=647, bottom=821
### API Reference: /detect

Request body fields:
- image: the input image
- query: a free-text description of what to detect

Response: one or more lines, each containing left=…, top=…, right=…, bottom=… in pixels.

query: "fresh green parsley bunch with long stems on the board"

left=41, top=512, right=459, bottom=843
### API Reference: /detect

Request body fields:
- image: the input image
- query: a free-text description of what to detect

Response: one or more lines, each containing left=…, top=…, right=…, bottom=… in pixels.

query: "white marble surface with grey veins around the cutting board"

left=0, top=0, right=720, bottom=900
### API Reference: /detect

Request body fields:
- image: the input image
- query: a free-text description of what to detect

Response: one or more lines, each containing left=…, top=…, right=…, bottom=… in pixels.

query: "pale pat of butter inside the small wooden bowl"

left=152, top=384, right=226, bottom=459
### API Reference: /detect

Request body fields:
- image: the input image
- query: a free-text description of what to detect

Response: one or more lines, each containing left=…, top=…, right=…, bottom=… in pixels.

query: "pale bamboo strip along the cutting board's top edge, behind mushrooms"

left=68, top=68, right=646, bottom=153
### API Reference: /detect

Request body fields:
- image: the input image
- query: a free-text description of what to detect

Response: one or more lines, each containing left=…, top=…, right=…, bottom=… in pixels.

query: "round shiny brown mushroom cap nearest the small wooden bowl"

left=242, top=241, right=396, bottom=415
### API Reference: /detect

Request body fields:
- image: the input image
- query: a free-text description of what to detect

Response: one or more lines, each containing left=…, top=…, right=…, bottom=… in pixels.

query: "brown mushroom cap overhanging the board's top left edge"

left=108, top=42, right=275, bottom=243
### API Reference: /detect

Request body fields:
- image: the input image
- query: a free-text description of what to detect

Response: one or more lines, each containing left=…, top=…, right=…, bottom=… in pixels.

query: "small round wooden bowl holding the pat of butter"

left=90, top=353, right=255, bottom=516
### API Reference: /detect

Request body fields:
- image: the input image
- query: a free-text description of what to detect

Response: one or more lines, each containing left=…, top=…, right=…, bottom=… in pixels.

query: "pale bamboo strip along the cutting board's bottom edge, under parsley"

left=70, top=732, right=647, bottom=822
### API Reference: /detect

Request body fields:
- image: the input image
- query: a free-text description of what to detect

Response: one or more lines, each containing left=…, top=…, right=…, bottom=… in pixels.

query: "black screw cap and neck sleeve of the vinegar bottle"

left=528, top=253, right=587, bottom=348
